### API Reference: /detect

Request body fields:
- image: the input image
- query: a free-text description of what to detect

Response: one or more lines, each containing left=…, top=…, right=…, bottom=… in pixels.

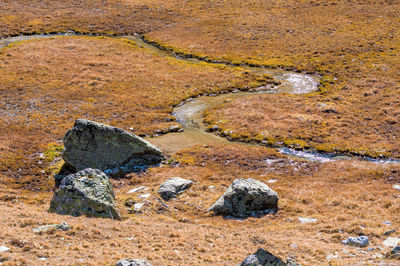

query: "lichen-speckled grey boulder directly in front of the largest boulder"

left=49, top=168, right=121, bottom=220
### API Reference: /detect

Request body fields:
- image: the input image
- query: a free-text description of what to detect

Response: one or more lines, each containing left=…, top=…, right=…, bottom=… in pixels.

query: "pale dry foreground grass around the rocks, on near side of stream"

left=0, top=145, right=400, bottom=265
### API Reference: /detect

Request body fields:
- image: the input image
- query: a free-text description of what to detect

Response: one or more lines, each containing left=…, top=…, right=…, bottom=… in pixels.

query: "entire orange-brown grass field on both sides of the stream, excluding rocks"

left=0, top=0, right=400, bottom=265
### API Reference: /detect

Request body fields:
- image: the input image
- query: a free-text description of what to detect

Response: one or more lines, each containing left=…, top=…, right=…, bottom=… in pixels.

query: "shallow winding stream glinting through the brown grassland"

left=0, top=32, right=400, bottom=163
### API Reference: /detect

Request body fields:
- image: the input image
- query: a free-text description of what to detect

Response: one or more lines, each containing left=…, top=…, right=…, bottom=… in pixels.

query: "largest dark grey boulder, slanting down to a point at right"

left=63, top=119, right=163, bottom=174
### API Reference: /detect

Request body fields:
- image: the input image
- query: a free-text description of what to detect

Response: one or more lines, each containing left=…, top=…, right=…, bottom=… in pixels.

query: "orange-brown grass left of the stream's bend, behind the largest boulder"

left=0, top=37, right=266, bottom=189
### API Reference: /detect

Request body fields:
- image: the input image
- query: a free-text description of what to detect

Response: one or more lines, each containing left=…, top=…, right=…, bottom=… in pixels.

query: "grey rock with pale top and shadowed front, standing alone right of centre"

left=208, top=178, right=279, bottom=217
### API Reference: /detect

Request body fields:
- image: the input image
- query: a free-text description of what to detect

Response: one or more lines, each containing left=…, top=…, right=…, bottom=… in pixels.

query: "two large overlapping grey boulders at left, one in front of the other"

left=49, top=119, right=164, bottom=220
